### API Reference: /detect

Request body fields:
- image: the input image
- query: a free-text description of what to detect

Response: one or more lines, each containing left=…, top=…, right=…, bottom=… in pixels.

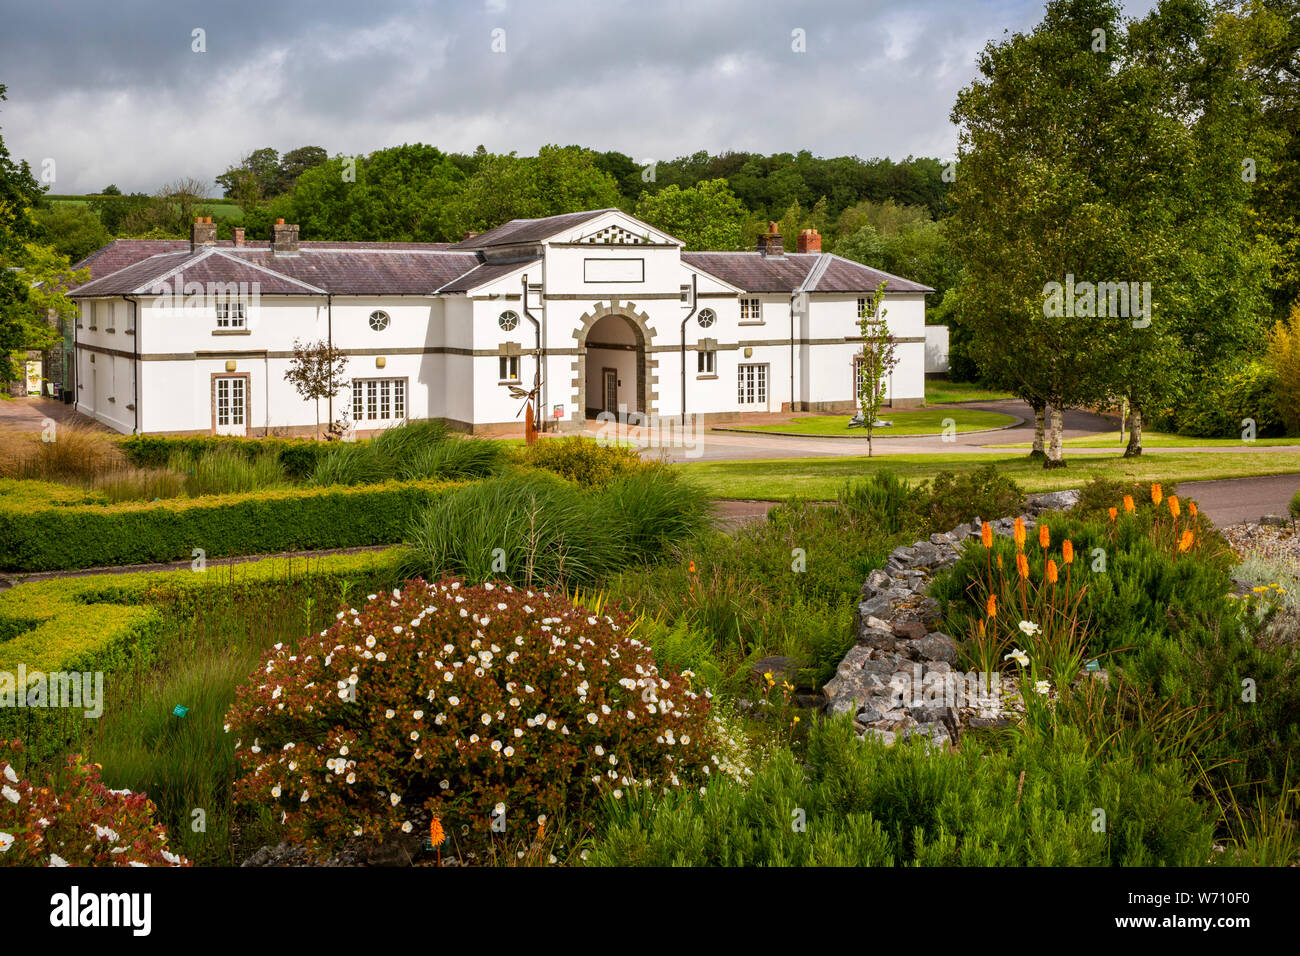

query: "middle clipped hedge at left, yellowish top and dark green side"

left=0, top=481, right=456, bottom=571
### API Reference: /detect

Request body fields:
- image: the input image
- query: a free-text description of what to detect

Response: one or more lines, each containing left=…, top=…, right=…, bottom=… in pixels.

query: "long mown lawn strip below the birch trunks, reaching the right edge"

left=676, top=451, right=1300, bottom=499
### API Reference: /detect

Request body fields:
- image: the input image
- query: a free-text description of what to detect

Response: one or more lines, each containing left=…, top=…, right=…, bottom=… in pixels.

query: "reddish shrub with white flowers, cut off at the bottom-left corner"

left=0, top=740, right=190, bottom=866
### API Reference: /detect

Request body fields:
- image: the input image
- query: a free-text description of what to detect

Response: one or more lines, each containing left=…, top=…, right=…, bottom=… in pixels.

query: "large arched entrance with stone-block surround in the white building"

left=573, top=299, right=658, bottom=419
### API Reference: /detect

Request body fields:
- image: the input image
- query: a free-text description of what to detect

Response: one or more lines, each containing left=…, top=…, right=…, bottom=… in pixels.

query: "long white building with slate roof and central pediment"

left=72, top=209, right=931, bottom=434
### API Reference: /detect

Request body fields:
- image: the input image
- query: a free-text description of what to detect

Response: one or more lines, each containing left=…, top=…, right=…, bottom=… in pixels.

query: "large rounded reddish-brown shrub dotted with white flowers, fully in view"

left=226, top=579, right=715, bottom=848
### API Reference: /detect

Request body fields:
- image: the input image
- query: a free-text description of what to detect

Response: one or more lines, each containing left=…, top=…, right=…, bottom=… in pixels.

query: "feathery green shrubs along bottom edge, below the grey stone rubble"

left=588, top=719, right=1212, bottom=866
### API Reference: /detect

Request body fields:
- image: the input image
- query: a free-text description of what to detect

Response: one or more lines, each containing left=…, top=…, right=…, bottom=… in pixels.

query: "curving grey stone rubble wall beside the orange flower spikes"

left=824, top=490, right=1079, bottom=747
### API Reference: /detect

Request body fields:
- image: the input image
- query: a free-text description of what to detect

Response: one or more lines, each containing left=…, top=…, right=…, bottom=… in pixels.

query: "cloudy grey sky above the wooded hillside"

left=0, top=0, right=1153, bottom=195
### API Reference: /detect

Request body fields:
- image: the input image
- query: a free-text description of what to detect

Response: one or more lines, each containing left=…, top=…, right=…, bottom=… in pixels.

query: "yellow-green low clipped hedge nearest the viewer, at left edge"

left=0, top=549, right=398, bottom=758
